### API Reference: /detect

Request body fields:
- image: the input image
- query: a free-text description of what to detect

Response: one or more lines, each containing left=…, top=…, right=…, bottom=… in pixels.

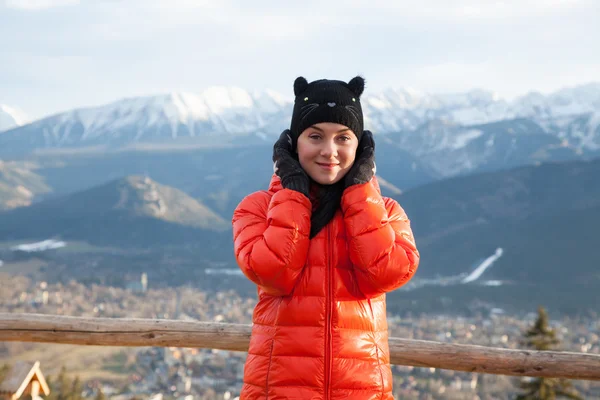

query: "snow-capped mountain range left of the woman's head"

left=4, top=87, right=290, bottom=151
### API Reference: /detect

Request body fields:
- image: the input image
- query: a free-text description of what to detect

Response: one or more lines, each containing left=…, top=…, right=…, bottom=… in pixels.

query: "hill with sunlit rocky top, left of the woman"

left=0, top=176, right=229, bottom=246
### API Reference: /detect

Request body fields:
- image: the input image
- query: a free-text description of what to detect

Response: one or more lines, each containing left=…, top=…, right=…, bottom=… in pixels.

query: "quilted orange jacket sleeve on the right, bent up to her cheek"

left=342, top=182, right=419, bottom=297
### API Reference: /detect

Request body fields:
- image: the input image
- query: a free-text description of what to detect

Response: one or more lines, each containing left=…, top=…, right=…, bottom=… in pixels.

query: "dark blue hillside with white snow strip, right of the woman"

left=390, top=160, right=600, bottom=312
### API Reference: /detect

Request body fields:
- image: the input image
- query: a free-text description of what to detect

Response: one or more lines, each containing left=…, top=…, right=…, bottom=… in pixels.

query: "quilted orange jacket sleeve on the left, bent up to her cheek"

left=232, top=189, right=311, bottom=296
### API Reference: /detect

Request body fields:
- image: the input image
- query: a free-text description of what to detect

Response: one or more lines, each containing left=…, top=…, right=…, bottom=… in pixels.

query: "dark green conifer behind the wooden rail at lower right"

left=516, top=306, right=583, bottom=400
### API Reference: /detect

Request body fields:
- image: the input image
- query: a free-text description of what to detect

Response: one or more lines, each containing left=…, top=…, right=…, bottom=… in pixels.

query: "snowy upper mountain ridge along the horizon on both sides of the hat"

left=0, top=83, right=600, bottom=150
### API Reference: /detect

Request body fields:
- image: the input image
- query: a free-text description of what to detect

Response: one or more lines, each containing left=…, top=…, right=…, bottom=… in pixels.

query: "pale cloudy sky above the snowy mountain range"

left=0, top=0, right=600, bottom=118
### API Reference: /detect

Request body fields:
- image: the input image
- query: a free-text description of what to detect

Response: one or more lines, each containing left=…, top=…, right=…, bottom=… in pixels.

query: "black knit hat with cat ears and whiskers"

left=290, top=76, right=365, bottom=149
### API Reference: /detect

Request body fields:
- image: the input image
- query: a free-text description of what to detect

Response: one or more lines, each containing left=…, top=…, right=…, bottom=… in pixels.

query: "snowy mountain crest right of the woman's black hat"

left=364, top=83, right=600, bottom=150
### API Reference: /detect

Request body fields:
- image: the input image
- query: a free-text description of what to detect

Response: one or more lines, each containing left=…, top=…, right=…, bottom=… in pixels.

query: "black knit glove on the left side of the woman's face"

left=273, top=129, right=310, bottom=197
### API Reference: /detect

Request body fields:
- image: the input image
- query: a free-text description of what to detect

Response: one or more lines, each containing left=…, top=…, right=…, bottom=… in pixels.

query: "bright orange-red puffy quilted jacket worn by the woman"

left=233, top=175, right=419, bottom=400
